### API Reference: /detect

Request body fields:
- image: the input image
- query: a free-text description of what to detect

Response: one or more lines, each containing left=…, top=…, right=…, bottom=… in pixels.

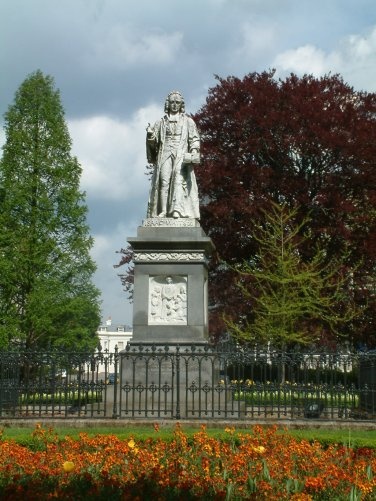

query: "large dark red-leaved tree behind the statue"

left=121, top=71, right=376, bottom=346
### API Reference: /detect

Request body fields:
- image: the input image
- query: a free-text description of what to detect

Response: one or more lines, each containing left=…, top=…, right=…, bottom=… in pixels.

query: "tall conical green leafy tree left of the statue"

left=0, top=71, right=100, bottom=350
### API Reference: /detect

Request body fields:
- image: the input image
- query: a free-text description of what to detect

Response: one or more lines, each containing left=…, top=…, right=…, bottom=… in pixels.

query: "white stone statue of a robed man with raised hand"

left=146, top=91, right=200, bottom=219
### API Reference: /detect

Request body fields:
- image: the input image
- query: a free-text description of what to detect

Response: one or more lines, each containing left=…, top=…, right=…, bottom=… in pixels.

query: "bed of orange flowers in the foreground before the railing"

left=0, top=425, right=376, bottom=501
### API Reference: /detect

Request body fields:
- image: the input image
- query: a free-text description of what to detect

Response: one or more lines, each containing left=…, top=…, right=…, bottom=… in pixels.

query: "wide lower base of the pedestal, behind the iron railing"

left=120, top=343, right=244, bottom=419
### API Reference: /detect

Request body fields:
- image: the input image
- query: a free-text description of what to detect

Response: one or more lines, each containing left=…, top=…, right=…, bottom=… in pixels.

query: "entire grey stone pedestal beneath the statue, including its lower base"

left=119, top=218, right=239, bottom=418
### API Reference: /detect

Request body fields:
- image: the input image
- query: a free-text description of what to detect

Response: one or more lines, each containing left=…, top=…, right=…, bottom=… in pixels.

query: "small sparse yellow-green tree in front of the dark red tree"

left=228, top=203, right=356, bottom=348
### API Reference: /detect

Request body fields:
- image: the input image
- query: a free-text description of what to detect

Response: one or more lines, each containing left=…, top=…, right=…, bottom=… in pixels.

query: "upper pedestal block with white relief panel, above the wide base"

left=128, top=218, right=214, bottom=344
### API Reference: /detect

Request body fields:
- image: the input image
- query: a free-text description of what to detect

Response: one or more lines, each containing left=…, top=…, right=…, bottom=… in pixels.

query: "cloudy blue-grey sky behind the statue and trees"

left=0, top=0, right=376, bottom=325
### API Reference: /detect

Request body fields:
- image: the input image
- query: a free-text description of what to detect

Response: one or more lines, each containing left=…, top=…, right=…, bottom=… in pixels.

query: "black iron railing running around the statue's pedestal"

left=0, top=344, right=376, bottom=420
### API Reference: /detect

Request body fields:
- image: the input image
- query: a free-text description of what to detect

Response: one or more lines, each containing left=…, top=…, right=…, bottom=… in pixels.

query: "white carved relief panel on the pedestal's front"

left=148, top=276, right=187, bottom=325
